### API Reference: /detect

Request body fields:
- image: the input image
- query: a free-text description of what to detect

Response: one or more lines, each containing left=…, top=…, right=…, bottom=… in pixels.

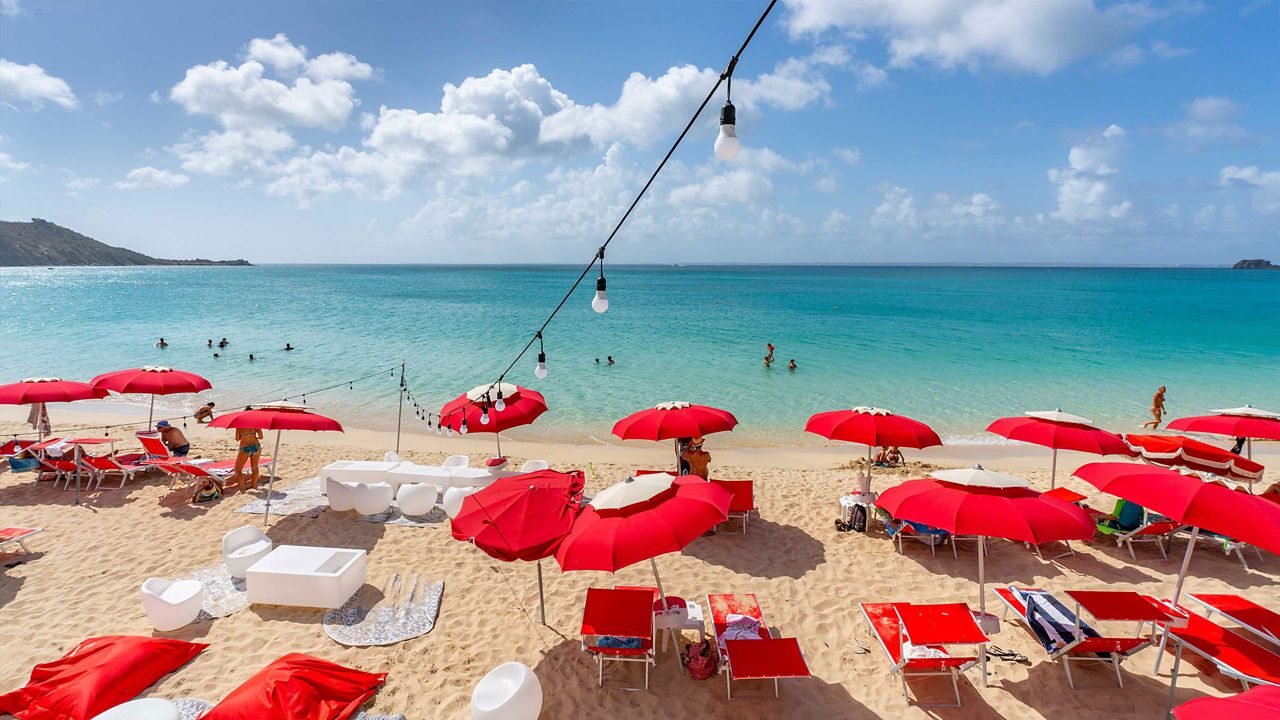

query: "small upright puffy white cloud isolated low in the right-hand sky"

left=1048, top=124, right=1133, bottom=223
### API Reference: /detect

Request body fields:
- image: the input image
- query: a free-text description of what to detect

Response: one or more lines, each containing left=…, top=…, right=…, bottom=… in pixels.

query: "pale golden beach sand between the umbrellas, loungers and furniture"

left=0, top=411, right=1280, bottom=720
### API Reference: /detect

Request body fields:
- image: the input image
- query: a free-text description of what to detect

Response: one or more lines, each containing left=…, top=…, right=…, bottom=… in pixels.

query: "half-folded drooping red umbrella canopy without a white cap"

left=453, top=470, right=584, bottom=562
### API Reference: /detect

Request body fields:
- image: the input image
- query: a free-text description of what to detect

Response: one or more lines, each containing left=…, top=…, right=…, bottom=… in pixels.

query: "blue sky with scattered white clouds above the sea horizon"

left=0, top=0, right=1280, bottom=264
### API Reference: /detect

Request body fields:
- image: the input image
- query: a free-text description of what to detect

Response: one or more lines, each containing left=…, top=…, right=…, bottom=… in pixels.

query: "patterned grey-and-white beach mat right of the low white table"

left=324, top=573, right=444, bottom=647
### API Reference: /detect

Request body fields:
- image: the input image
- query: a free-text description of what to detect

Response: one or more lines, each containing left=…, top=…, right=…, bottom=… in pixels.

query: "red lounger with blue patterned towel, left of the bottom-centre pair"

left=581, top=588, right=657, bottom=689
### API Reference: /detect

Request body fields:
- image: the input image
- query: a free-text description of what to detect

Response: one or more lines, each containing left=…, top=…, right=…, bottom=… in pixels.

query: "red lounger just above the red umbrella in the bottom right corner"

left=1143, top=596, right=1280, bottom=711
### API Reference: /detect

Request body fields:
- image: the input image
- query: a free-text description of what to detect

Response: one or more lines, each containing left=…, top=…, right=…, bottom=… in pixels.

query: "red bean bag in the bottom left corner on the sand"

left=0, top=635, right=209, bottom=720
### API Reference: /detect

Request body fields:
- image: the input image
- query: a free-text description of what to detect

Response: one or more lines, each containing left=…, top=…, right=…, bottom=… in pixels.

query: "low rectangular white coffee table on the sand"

left=244, top=544, right=367, bottom=609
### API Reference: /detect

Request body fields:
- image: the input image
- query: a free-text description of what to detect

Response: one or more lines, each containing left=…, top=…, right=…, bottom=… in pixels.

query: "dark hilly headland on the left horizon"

left=0, top=218, right=251, bottom=268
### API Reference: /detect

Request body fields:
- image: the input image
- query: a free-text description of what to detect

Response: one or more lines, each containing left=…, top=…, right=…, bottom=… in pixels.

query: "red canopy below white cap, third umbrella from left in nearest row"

left=876, top=479, right=1094, bottom=544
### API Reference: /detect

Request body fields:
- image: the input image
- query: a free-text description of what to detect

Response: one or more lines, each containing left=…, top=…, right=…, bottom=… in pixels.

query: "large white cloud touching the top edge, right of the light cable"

left=786, top=0, right=1157, bottom=74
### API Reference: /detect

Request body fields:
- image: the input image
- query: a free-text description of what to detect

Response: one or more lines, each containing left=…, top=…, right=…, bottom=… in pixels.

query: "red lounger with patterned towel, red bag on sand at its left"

left=707, top=593, right=810, bottom=700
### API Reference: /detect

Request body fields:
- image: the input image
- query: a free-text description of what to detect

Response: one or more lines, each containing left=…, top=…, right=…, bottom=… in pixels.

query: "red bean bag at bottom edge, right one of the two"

left=201, top=652, right=387, bottom=720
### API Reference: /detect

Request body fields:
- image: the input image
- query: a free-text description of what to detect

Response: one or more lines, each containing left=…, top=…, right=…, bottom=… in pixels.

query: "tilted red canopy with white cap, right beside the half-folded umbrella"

left=556, top=475, right=733, bottom=573
